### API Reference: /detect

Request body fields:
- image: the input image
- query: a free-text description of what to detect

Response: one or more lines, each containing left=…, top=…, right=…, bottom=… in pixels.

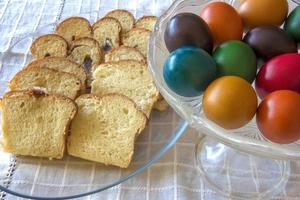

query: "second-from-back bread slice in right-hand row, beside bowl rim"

left=122, top=28, right=151, bottom=57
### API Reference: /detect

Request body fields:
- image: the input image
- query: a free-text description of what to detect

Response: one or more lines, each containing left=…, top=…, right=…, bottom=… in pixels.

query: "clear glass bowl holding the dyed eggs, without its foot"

left=148, top=0, right=300, bottom=160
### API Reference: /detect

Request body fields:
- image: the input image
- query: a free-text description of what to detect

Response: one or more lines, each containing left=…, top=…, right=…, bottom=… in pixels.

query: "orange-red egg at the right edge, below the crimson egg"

left=256, top=90, right=300, bottom=144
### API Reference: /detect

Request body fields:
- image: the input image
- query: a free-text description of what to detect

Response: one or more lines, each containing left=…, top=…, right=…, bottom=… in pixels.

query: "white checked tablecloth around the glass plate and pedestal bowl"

left=0, top=0, right=300, bottom=200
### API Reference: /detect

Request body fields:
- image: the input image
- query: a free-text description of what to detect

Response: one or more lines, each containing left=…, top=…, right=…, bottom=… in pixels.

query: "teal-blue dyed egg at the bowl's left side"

left=163, top=47, right=216, bottom=97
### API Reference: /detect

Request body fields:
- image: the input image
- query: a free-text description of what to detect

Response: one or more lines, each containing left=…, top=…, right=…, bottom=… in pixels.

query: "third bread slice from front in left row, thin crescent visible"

left=26, top=57, right=87, bottom=89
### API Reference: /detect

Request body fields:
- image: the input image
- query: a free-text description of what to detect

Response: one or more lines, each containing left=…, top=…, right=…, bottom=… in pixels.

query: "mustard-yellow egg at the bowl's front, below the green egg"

left=202, top=76, right=257, bottom=129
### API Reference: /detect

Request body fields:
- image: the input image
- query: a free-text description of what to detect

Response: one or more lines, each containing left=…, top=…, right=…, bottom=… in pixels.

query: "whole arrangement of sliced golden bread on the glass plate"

left=1, top=10, right=168, bottom=168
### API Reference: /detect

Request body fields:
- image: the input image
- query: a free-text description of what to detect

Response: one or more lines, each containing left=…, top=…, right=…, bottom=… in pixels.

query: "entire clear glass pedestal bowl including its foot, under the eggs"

left=148, top=0, right=300, bottom=199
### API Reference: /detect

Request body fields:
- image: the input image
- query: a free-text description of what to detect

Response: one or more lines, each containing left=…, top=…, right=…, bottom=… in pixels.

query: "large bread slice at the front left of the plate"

left=1, top=91, right=77, bottom=159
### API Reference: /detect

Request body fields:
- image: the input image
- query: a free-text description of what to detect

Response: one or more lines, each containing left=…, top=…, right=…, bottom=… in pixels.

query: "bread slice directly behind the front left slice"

left=9, top=67, right=82, bottom=99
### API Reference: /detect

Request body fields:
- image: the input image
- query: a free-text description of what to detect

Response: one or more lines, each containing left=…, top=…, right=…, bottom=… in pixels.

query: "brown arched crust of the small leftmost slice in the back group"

left=30, top=33, right=68, bottom=58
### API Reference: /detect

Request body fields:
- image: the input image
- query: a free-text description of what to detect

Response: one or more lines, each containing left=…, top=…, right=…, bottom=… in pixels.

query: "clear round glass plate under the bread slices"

left=0, top=9, right=188, bottom=199
